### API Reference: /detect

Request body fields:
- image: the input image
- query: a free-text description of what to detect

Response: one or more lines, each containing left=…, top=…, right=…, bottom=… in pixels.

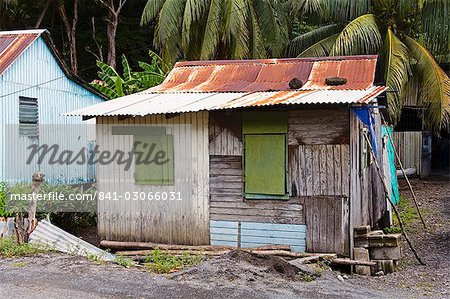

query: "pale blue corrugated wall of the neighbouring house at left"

left=0, top=38, right=102, bottom=183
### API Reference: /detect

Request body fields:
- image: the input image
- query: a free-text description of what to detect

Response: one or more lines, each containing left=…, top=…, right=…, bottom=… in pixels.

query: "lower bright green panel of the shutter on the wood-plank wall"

left=244, top=134, right=286, bottom=195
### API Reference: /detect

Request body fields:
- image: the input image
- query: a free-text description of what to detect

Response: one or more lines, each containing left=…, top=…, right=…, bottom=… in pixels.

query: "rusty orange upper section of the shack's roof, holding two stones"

left=147, top=55, right=377, bottom=92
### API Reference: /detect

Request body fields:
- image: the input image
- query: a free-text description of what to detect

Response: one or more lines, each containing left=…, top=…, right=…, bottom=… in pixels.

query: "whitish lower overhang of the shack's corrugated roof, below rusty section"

left=66, top=86, right=386, bottom=116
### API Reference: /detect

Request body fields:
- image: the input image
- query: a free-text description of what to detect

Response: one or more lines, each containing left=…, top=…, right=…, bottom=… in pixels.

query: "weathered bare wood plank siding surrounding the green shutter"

left=209, top=108, right=350, bottom=254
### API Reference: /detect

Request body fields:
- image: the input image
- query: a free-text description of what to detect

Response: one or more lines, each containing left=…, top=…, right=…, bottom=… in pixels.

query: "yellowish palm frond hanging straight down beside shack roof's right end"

left=383, top=28, right=411, bottom=123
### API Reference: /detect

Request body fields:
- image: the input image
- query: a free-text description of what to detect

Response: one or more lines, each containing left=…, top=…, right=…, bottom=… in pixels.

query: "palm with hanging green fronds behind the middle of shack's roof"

left=141, top=0, right=289, bottom=63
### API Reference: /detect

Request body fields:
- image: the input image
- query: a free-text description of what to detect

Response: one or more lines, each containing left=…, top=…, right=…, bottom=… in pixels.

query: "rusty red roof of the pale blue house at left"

left=0, top=30, right=45, bottom=76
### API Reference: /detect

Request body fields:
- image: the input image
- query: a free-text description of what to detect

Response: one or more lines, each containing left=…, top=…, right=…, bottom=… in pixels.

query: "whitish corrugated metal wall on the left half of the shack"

left=97, top=112, right=209, bottom=245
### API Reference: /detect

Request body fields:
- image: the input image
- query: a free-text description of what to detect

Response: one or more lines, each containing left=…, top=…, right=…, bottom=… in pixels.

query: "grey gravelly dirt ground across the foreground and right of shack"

left=0, top=178, right=450, bottom=299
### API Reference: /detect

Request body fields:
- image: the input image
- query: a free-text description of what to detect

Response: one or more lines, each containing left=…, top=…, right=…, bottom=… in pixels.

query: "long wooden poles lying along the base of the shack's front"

left=100, top=240, right=375, bottom=267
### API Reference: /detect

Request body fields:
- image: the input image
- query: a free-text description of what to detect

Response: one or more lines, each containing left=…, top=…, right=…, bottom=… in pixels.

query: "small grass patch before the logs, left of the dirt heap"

left=144, top=249, right=202, bottom=274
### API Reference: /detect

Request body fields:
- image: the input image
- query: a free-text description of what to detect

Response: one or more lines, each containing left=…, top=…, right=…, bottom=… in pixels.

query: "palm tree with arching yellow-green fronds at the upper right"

left=288, top=0, right=450, bottom=131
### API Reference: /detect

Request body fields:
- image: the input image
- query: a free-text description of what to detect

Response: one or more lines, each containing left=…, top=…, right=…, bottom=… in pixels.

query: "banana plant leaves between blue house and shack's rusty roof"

left=91, top=51, right=170, bottom=99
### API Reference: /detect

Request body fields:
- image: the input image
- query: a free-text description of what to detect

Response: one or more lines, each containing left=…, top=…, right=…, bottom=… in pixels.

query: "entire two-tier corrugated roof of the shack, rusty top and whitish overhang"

left=67, top=56, right=386, bottom=116
